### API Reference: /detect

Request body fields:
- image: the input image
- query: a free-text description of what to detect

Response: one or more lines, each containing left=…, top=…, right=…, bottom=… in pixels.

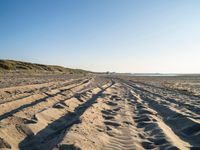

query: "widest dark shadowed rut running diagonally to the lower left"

left=20, top=83, right=113, bottom=149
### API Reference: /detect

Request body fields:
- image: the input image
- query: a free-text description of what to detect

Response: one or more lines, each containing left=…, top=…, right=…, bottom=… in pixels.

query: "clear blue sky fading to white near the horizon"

left=0, top=0, right=200, bottom=73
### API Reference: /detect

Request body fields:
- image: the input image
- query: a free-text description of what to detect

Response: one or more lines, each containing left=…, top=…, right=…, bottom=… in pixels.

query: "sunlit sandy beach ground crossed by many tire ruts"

left=0, top=75, right=200, bottom=150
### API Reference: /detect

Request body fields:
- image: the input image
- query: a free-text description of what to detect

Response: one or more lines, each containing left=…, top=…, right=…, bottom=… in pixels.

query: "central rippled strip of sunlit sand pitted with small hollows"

left=102, top=84, right=143, bottom=150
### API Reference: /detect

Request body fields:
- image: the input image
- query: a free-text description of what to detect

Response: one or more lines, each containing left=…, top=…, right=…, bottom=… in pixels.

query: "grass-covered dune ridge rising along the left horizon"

left=0, top=60, right=89, bottom=74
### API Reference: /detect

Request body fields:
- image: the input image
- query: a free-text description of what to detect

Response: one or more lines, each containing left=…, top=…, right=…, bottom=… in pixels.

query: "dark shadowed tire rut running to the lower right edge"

left=122, top=79, right=200, bottom=148
